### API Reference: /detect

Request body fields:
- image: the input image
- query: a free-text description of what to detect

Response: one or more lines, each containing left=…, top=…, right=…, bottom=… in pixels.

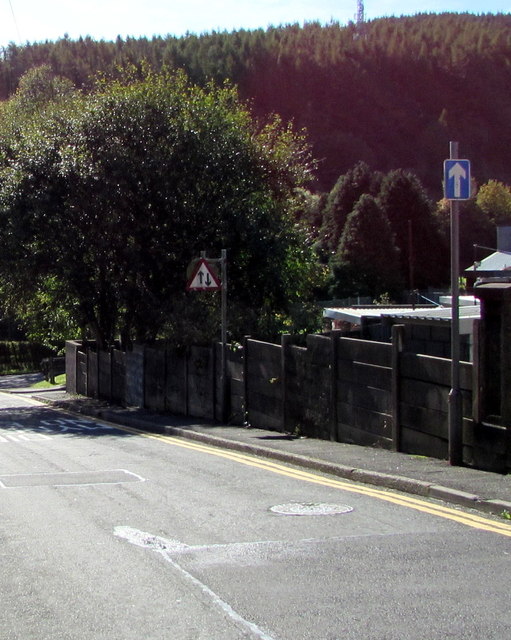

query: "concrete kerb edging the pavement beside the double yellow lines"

left=34, top=397, right=511, bottom=515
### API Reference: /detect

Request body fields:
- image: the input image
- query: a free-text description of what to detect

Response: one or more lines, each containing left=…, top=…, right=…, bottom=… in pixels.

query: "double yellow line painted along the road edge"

left=115, top=425, right=511, bottom=538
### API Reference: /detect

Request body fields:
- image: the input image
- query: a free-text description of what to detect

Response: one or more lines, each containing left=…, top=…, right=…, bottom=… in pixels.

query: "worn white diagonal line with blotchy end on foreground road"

left=114, top=527, right=274, bottom=640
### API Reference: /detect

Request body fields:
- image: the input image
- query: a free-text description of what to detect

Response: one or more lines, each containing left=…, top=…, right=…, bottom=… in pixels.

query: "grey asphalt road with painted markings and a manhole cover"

left=0, top=393, right=511, bottom=640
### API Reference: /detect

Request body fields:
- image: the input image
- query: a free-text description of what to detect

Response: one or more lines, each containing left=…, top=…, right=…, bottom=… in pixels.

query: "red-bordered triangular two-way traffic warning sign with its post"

left=186, top=249, right=228, bottom=422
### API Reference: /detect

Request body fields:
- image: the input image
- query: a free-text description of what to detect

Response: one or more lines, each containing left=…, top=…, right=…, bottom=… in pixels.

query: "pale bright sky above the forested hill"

left=0, top=0, right=511, bottom=47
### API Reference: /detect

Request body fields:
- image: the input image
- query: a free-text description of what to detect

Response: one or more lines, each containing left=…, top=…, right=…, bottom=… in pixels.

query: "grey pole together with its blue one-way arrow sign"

left=444, top=142, right=471, bottom=466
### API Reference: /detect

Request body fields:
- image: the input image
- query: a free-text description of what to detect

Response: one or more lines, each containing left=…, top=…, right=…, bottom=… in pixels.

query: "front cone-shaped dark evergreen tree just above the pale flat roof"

left=330, top=194, right=402, bottom=297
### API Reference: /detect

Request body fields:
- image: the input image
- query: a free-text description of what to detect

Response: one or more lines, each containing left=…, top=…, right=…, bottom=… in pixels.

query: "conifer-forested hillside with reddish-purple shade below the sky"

left=0, top=14, right=511, bottom=197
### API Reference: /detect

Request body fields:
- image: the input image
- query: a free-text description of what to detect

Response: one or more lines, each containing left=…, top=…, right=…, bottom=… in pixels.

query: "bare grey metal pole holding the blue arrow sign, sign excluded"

left=449, top=142, right=463, bottom=466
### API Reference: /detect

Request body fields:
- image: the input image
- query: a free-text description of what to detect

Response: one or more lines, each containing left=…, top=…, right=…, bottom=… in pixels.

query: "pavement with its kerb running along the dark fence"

left=0, top=374, right=511, bottom=526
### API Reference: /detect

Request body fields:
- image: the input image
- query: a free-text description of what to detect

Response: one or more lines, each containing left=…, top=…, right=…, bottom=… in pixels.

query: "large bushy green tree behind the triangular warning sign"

left=0, top=71, right=315, bottom=344
